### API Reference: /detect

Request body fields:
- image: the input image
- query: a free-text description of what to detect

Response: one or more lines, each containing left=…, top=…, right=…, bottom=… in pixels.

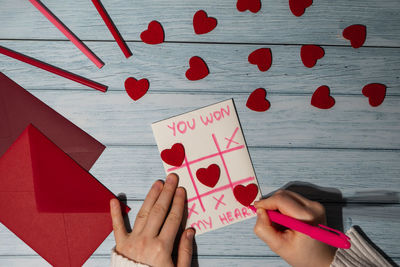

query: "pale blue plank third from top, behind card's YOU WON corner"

left=14, top=90, right=400, bottom=149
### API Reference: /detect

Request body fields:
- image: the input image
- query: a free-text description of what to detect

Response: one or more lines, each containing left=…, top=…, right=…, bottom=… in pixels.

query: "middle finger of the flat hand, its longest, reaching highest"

left=144, top=174, right=178, bottom=236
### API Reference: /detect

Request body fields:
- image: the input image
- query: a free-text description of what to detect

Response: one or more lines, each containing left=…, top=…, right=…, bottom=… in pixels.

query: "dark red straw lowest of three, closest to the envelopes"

left=0, top=45, right=107, bottom=92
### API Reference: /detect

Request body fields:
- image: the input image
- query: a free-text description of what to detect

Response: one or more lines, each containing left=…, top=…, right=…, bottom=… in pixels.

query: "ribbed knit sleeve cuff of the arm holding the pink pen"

left=331, top=227, right=392, bottom=267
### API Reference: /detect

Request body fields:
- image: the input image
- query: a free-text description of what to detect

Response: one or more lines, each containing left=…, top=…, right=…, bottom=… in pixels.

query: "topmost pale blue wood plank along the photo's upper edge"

left=0, top=0, right=400, bottom=46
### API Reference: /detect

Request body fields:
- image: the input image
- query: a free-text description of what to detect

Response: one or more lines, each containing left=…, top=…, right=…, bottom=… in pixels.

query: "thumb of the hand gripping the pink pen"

left=254, top=208, right=284, bottom=252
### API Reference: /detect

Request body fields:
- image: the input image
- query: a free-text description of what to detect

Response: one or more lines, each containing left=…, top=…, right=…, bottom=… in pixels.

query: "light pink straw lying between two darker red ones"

left=29, top=0, right=104, bottom=68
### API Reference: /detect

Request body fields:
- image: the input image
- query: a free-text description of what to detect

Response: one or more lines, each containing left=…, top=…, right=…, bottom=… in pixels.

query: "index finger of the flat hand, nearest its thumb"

left=159, top=187, right=186, bottom=244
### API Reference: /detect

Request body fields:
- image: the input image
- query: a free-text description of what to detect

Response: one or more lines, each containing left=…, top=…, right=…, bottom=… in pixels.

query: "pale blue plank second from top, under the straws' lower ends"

left=0, top=41, right=400, bottom=95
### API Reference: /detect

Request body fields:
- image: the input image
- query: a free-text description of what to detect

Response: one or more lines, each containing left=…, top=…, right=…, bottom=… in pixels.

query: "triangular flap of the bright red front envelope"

left=27, top=125, right=115, bottom=213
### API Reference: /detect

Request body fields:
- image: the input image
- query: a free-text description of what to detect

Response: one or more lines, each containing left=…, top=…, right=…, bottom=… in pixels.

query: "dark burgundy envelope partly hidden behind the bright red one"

left=0, top=72, right=105, bottom=170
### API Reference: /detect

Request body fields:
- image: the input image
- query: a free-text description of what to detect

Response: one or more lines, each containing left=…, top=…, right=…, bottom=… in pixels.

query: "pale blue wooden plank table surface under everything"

left=0, top=0, right=400, bottom=267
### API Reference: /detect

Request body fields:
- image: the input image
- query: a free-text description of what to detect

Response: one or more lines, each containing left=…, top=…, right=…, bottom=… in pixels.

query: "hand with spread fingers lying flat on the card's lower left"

left=110, top=174, right=194, bottom=267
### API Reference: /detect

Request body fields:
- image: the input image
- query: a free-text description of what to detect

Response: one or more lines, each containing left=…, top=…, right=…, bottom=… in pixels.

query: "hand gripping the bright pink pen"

left=254, top=190, right=336, bottom=267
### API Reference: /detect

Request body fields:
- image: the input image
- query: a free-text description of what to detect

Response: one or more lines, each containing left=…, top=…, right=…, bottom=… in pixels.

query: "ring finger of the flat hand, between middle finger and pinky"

left=132, top=181, right=163, bottom=233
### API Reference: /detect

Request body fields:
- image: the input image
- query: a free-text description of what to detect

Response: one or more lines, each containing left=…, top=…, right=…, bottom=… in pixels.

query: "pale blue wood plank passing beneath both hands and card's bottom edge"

left=0, top=201, right=400, bottom=257
